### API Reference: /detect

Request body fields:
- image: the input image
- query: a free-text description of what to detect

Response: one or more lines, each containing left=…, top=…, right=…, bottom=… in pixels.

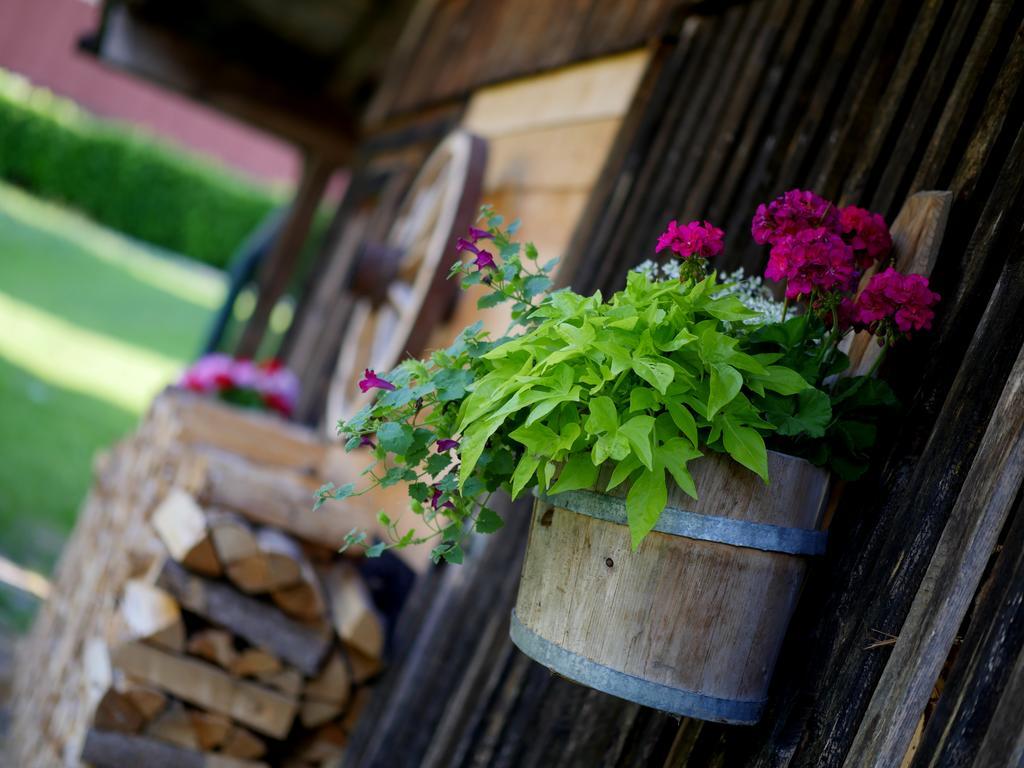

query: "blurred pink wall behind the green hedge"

left=0, top=0, right=299, bottom=181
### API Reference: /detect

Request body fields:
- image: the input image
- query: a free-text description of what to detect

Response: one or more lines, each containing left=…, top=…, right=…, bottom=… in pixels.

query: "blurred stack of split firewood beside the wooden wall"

left=10, top=392, right=393, bottom=768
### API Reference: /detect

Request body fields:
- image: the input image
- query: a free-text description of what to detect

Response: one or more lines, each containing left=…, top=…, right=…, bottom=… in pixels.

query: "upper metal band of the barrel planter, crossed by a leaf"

left=537, top=490, right=828, bottom=555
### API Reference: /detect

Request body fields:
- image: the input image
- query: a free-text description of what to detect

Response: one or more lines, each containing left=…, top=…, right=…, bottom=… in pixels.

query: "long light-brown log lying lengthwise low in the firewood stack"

left=112, top=643, right=297, bottom=738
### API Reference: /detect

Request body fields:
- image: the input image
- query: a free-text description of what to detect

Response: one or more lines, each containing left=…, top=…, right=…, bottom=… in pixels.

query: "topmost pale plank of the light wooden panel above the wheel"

left=463, top=50, right=647, bottom=138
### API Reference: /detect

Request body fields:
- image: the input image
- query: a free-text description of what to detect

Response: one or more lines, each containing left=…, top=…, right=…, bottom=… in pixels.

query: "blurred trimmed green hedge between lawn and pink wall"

left=0, top=70, right=282, bottom=267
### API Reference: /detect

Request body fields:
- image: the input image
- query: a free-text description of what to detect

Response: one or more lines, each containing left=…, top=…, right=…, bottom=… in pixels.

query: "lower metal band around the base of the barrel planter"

left=509, top=610, right=765, bottom=725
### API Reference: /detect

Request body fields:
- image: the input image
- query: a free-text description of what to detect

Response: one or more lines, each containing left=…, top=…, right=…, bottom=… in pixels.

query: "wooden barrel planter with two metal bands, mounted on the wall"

left=511, top=452, right=828, bottom=724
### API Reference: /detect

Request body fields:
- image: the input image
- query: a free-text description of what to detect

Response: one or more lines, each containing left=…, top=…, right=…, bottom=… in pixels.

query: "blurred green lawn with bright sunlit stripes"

left=0, top=179, right=224, bottom=618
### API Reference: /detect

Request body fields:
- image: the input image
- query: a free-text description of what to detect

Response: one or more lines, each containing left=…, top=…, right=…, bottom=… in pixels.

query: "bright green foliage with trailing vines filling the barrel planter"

left=316, top=195, right=937, bottom=562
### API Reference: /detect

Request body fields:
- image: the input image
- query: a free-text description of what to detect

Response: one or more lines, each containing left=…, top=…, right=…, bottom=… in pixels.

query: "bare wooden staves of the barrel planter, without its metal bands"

left=516, top=454, right=828, bottom=701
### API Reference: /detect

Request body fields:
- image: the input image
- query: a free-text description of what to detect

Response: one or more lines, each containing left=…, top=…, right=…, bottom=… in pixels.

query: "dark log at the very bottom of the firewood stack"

left=82, top=729, right=267, bottom=768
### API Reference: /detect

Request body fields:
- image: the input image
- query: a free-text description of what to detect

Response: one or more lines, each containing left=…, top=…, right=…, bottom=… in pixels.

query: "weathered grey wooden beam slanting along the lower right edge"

left=845, top=342, right=1024, bottom=768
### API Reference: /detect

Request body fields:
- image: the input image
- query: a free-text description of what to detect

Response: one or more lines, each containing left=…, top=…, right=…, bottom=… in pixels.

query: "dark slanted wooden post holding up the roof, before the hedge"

left=234, top=152, right=335, bottom=357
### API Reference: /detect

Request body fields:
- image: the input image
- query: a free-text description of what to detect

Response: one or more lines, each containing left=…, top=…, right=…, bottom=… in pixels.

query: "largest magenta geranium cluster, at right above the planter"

left=751, top=189, right=939, bottom=334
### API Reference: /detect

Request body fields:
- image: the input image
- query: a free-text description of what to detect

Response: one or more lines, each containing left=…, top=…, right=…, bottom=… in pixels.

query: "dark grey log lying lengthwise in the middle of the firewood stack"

left=158, top=562, right=332, bottom=675
